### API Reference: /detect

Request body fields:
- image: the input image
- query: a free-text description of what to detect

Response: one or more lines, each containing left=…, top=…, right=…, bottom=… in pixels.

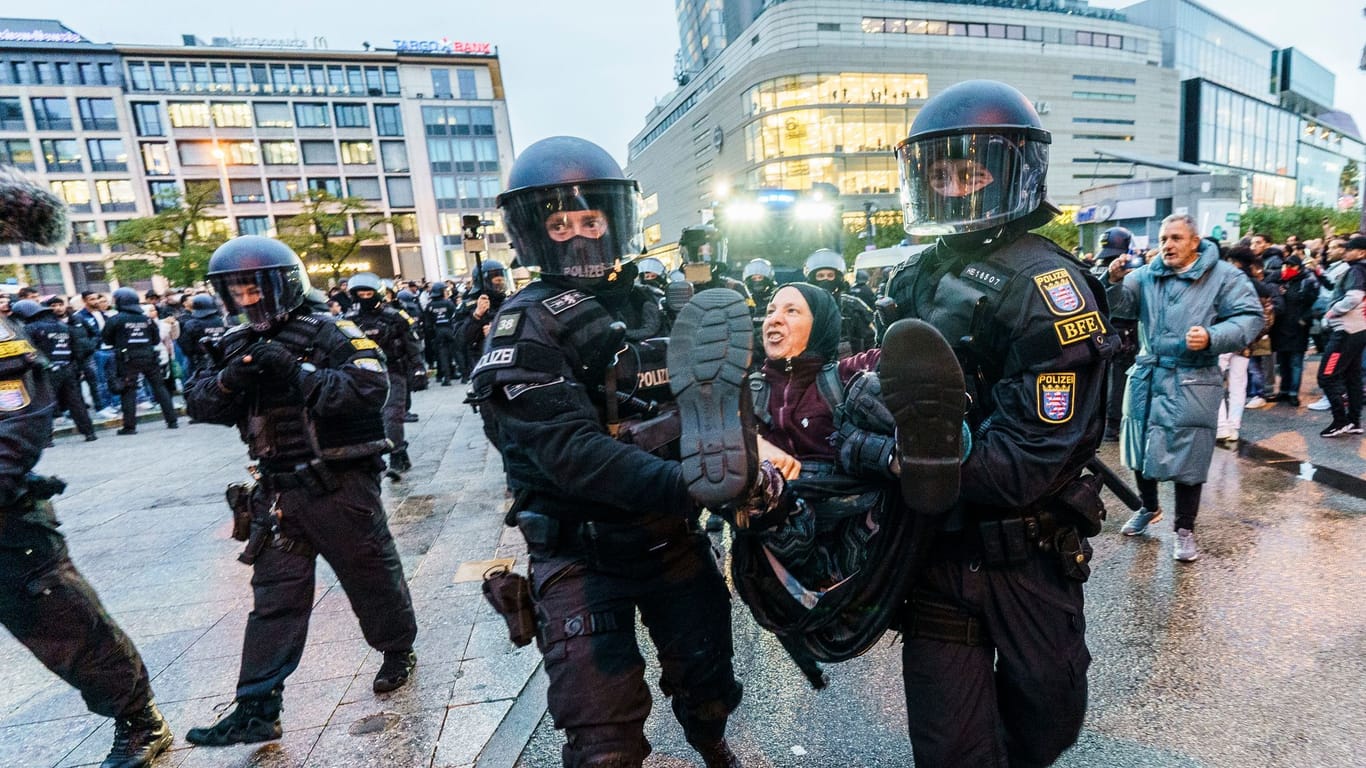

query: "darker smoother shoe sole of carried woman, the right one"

left=877, top=320, right=967, bottom=514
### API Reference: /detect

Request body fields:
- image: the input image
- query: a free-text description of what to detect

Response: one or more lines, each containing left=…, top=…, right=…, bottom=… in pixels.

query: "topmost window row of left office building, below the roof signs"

left=128, top=60, right=402, bottom=96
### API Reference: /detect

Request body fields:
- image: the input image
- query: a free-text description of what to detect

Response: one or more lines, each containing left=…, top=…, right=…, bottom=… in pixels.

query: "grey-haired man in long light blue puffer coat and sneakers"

left=1105, top=215, right=1264, bottom=563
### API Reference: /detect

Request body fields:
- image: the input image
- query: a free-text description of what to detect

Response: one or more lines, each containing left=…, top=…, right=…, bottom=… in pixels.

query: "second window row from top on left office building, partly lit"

left=133, top=101, right=404, bottom=137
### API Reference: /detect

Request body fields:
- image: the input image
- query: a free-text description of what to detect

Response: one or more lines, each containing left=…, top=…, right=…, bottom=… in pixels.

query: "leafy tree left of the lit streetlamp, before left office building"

left=105, top=186, right=228, bottom=286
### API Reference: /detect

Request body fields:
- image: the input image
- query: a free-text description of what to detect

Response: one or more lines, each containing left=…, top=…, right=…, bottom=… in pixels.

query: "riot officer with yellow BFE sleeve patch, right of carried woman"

left=882, top=81, right=1113, bottom=768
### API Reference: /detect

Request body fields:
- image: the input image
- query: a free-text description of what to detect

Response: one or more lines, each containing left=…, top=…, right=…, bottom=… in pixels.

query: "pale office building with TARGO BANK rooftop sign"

left=0, top=19, right=512, bottom=292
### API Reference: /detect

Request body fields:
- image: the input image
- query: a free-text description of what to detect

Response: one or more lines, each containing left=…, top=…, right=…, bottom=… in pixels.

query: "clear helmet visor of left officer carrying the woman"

left=501, top=180, right=645, bottom=280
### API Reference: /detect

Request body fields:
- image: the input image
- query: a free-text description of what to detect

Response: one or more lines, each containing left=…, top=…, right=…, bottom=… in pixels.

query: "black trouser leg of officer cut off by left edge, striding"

left=0, top=502, right=152, bottom=717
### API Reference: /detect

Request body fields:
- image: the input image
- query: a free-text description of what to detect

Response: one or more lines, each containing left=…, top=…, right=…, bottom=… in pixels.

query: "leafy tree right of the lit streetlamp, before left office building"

left=280, top=190, right=389, bottom=280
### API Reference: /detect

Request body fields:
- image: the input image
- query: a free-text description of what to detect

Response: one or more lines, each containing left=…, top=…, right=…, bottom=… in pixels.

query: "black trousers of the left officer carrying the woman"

left=529, top=519, right=740, bottom=768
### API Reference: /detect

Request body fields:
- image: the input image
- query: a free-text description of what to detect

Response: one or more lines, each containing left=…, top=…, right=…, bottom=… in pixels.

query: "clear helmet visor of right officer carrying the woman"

left=896, top=134, right=1048, bottom=236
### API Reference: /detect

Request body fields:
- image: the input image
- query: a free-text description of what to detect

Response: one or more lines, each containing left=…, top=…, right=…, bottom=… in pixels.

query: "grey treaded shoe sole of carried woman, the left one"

left=668, top=288, right=758, bottom=510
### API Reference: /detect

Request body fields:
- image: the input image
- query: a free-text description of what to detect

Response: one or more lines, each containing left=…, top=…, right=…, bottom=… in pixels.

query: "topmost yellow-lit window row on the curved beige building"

left=742, top=72, right=930, bottom=117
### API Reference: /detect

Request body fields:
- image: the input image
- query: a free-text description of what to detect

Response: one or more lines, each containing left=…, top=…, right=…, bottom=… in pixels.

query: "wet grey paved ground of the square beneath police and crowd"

left=0, top=358, right=1366, bottom=768
